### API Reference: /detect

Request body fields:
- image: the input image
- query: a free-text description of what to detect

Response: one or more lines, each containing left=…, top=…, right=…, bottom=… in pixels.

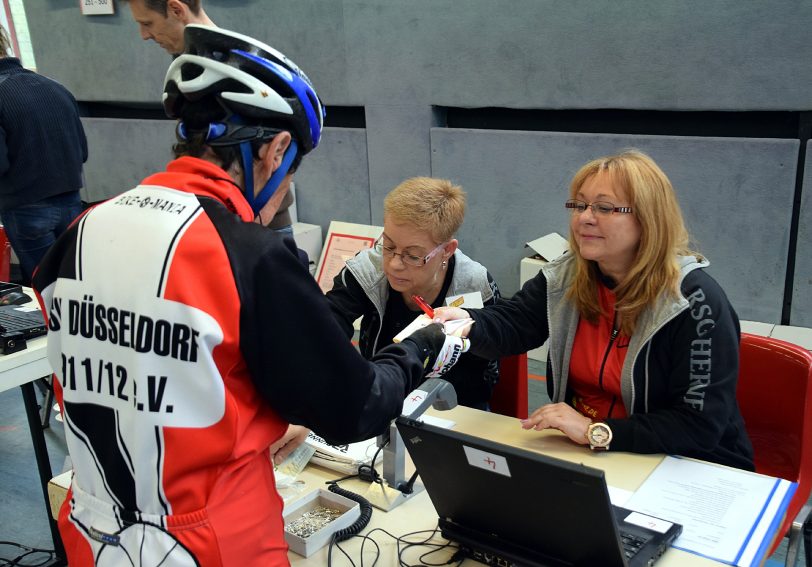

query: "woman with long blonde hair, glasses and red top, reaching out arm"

left=436, top=150, right=753, bottom=470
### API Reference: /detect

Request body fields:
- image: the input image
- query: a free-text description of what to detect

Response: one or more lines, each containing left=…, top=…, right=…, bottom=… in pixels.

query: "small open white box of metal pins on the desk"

left=282, top=488, right=361, bottom=557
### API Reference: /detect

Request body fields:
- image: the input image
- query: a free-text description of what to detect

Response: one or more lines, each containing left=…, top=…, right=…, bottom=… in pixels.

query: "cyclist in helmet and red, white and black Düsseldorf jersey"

left=34, top=26, right=465, bottom=567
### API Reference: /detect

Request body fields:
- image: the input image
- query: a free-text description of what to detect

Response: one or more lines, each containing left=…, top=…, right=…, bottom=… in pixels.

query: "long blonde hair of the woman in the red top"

left=568, top=149, right=701, bottom=336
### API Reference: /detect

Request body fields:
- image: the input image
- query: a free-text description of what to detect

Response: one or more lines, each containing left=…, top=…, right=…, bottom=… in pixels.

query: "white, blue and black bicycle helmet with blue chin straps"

left=163, top=24, right=325, bottom=214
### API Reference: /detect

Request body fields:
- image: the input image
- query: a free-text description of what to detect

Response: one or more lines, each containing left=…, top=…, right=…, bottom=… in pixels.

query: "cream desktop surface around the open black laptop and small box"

left=288, top=407, right=719, bottom=567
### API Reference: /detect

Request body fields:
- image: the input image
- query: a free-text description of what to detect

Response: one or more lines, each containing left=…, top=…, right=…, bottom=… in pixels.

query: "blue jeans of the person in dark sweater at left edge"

left=2, top=191, right=82, bottom=285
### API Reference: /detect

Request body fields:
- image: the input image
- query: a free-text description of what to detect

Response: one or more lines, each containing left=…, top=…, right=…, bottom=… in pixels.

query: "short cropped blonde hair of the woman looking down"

left=383, top=177, right=465, bottom=244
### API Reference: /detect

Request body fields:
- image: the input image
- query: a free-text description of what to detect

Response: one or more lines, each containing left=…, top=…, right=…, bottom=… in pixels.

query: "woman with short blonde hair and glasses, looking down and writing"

left=327, top=177, right=499, bottom=409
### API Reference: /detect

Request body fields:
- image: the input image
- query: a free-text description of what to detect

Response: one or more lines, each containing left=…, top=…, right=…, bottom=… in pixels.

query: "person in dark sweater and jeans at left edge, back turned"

left=0, top=26, right=87, bottom=285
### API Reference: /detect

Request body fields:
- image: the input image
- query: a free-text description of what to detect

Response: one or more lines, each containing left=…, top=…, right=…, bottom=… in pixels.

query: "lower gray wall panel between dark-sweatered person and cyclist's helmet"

left=82, top=118, right=175, bottom=202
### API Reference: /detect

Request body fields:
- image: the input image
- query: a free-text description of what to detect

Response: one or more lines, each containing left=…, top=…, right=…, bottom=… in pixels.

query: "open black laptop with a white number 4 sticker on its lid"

left=397, top=417, right=682, bottom=567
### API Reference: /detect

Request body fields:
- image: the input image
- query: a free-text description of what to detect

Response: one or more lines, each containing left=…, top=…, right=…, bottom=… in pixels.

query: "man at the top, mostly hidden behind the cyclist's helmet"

left=125, top=0, right=294, bottom=235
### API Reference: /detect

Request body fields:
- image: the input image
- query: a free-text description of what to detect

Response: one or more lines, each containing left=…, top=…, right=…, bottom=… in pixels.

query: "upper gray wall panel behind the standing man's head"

left=25, top=0, right=354, bottom=104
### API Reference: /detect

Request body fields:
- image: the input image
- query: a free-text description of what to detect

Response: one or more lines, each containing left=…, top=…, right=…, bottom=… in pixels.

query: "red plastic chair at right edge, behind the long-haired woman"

left=736, top=333, right=812, bottom=566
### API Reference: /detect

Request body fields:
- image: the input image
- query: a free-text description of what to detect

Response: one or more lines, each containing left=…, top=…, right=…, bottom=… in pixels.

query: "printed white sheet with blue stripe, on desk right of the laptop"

left=624, top=457, right=797, bottom=566
